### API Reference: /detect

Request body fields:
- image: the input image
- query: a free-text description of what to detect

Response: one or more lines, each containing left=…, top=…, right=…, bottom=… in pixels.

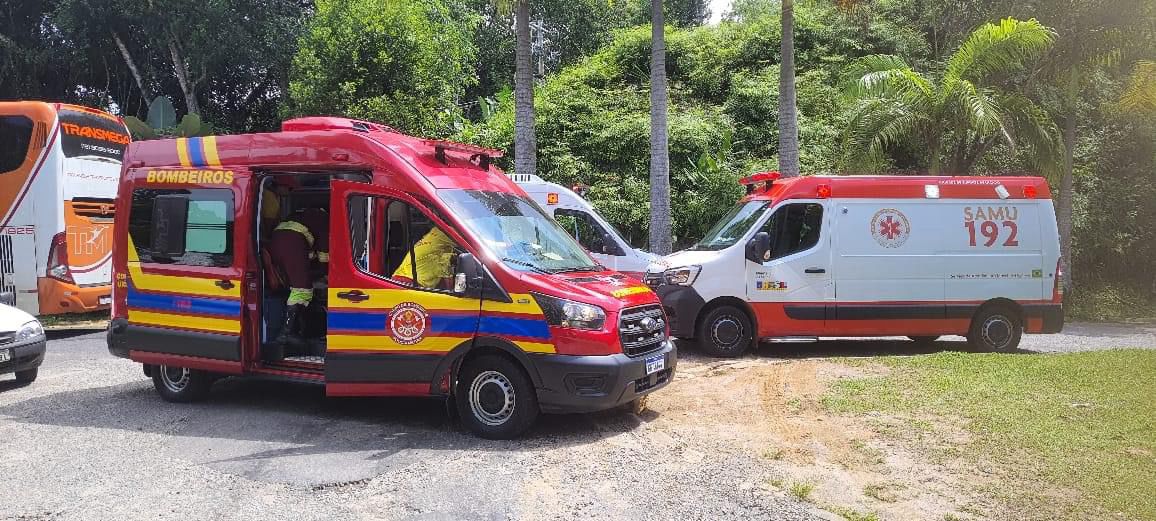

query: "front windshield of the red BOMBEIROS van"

left=438, top=189, right=602, bottom=273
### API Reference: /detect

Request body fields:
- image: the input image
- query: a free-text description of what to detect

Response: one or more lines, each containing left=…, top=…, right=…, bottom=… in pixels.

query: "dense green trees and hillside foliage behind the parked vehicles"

left=0, top=0, right=1156, bottom=318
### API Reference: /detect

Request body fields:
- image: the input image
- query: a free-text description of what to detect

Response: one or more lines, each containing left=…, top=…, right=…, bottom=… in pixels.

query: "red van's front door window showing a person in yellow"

left=349, top=195, right=465, bottom=291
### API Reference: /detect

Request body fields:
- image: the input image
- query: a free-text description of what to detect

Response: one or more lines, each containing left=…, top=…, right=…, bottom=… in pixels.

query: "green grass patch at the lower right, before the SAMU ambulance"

left=823, top=350, right=1156, bottom=519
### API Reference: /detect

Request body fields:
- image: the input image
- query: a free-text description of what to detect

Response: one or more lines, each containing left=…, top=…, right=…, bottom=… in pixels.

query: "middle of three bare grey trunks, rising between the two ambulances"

left=650, top=0, right=673, bottom=255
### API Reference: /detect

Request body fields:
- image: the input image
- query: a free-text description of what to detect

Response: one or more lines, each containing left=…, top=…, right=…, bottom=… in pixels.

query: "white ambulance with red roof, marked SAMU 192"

left=646, top=172, right=1064, bottom=356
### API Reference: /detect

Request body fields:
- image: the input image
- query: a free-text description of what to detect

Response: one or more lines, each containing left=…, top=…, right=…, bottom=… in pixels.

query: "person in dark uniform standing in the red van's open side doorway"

left=269, top=208, right=329, bottom=359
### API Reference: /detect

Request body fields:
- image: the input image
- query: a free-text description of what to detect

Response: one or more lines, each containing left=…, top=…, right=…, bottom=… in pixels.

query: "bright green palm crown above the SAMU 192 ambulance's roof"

left=844, top=18, right=1060, bottom=174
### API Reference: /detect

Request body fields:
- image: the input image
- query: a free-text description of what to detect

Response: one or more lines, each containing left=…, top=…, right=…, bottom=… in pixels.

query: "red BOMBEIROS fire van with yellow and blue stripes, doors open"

left=108, top=118, right=676, bottom=438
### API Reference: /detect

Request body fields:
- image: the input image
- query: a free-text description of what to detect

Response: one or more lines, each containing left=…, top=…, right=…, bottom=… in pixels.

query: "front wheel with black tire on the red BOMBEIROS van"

left=454, top=355, right=539, bottom=440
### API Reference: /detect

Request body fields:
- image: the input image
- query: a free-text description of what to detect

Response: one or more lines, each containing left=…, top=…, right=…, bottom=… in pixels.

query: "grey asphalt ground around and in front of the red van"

left=0, top=325, right=1156, bottom=520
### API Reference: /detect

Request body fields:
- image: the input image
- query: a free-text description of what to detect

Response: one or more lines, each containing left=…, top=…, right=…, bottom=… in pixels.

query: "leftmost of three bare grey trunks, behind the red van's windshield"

left=513, top=0, right=538, bottom=176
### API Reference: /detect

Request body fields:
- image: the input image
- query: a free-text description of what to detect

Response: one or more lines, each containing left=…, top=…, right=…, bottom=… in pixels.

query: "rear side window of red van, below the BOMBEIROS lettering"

left=128, top=188, right=234, bottom=267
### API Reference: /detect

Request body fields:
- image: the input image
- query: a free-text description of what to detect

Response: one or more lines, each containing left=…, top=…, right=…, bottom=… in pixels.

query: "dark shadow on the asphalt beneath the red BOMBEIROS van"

left=0, top=375, right=658, bottom=463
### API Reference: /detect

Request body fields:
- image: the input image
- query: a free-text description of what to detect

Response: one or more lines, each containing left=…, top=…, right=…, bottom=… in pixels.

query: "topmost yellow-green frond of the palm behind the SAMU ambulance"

left=943, top=17, right=1055, bottom=83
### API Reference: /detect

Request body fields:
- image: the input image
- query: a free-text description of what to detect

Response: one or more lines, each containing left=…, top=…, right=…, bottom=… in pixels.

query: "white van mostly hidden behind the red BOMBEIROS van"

left=509, top=173, right=658, bottom=280
